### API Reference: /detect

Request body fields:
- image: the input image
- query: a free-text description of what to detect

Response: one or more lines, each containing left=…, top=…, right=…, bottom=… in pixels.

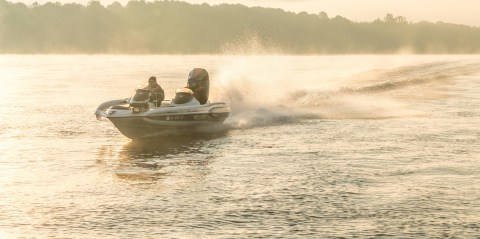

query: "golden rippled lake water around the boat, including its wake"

left=0, top=55, right=480, bottom=238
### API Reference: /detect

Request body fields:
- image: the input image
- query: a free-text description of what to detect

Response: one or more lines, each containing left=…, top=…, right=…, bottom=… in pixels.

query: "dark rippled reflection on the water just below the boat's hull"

left=97, top=134, right=226, bottom=183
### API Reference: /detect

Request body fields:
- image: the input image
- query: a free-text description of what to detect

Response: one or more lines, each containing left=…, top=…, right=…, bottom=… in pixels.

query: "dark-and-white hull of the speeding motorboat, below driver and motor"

left=96, top=101, right=230, bottom=139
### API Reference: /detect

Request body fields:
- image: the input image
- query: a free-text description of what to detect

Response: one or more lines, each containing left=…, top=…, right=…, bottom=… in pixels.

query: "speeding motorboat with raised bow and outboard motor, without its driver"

left=95, top=68, right=230, bottom=139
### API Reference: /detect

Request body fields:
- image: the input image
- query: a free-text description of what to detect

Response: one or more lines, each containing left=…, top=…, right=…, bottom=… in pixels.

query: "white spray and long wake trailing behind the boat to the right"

left=208, top=52, right=477, bottom=128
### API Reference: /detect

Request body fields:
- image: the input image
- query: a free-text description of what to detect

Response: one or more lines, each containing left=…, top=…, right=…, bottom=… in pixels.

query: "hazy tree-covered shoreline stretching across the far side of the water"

left=0, top=0, right=480, bottom=54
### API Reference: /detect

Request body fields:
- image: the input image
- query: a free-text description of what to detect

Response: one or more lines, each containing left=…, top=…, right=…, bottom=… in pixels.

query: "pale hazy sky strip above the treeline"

left=9, top=0, right=480, bottom=27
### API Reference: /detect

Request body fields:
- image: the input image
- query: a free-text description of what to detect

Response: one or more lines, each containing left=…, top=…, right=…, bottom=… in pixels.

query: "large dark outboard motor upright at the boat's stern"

left=187, top=68, right=210, bottom=105
